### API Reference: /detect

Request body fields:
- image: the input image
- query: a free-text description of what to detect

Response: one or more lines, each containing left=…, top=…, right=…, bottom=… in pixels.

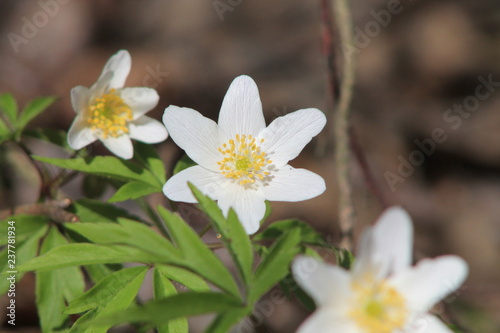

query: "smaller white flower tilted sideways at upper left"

left=68, top=50, right=168, bottom=159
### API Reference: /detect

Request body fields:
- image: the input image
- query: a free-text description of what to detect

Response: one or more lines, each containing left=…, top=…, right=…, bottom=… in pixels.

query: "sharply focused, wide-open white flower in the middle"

left=163, top=76, right=326, bottom=234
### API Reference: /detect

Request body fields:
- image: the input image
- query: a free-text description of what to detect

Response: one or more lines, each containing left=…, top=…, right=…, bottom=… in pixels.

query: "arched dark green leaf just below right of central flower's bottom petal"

left=252, top=219, right=328, bottom=246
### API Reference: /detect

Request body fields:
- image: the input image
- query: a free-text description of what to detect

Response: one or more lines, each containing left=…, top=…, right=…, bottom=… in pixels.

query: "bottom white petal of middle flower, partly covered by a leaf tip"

left=218, top=182, right=266, bottom=235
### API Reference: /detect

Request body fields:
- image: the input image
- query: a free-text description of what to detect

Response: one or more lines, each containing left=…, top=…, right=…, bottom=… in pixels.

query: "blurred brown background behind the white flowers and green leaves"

left=0, top=0, right=500, bottom=333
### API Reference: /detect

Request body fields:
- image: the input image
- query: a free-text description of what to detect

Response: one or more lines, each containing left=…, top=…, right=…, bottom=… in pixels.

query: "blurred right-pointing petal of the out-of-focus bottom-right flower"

left=389, top=256, right=468, bottom=312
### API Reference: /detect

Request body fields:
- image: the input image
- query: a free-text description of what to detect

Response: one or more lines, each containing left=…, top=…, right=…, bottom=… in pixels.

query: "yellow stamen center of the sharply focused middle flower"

left=217, top=134, right=273, bottom=185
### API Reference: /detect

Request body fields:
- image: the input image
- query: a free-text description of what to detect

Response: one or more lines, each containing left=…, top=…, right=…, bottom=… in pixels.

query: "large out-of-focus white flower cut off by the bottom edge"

left=292, top=208, right=468, bottom=333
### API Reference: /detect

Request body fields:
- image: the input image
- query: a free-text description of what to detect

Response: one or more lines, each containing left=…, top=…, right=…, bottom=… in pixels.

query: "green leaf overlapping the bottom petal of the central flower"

left=189, top=184, right=253, bottom=288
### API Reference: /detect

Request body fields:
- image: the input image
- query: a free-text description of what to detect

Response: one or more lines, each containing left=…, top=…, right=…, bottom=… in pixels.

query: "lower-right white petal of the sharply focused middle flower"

left=262, top=165, right=326, bottom=201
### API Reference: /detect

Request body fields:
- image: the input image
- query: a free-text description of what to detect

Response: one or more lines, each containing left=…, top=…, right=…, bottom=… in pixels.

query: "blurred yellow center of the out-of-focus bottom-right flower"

left=348, top=282, right=408, bottom=333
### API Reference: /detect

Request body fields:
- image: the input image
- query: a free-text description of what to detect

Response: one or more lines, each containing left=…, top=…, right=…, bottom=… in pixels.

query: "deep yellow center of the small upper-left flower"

left=87, top=89, right=132, bottom=139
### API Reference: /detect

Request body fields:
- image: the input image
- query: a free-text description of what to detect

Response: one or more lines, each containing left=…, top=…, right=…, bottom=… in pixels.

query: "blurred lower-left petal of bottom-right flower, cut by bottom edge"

left=297, top=308, right=365, bottom=333
